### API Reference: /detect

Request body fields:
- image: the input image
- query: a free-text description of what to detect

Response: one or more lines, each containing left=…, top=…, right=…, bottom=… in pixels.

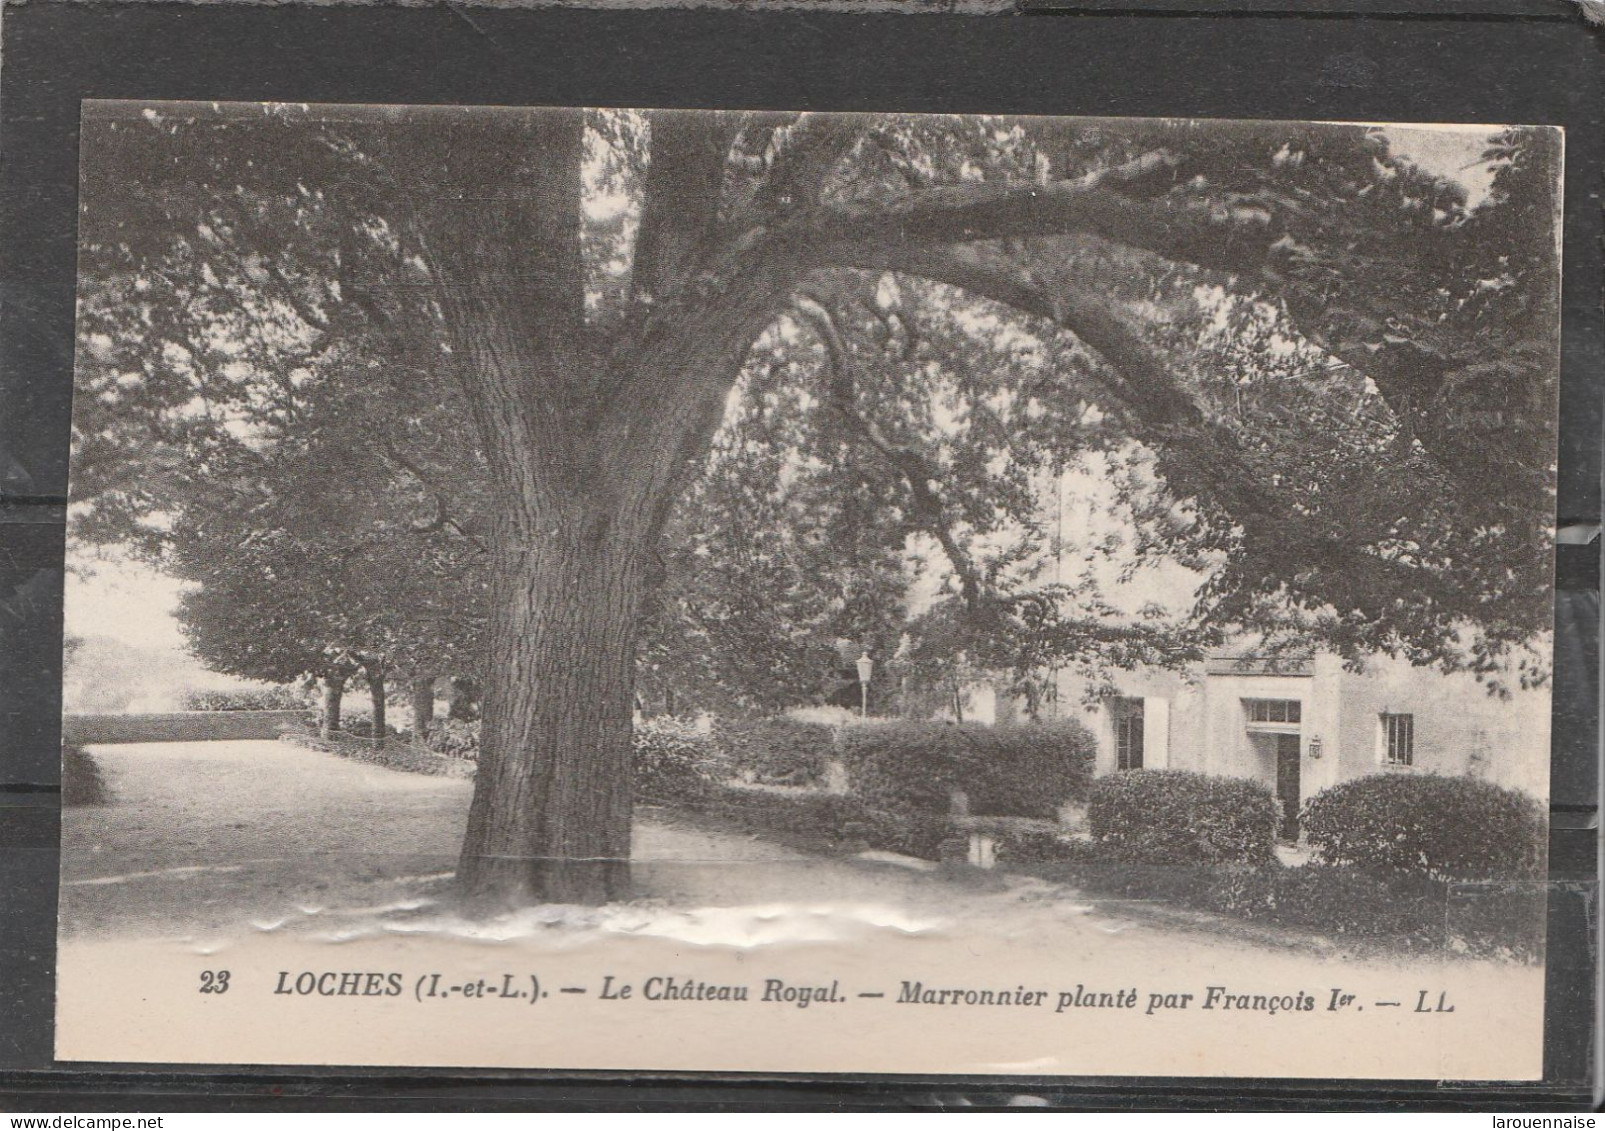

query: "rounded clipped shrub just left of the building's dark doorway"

left=1087, top=770, right=1281, bottom=865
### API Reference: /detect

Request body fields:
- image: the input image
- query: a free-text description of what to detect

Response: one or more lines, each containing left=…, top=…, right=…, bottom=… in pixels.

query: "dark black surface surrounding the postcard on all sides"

left=0, top=0, right=1605, bottom=1112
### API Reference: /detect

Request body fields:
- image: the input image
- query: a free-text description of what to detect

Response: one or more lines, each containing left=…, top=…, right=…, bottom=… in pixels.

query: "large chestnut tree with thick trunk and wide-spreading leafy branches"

left=75, top=104, right=1558, bottom=902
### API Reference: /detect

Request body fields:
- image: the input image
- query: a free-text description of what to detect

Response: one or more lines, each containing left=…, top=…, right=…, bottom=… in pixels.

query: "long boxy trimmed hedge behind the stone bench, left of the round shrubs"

left=841, top=722, right=1096, bottom=820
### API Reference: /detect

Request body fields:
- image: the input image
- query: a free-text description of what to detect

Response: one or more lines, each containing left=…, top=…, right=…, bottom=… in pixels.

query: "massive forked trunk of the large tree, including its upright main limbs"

left=392, top=111, right=798, bottom=906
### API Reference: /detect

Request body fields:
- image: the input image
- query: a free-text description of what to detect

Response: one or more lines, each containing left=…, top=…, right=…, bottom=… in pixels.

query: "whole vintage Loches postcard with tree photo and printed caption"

left=56, top=103, right=1562, bottom=1080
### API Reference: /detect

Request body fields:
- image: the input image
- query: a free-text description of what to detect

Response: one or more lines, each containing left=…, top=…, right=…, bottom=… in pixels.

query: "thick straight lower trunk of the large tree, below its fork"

left=457, top=504, right=647, bottom=905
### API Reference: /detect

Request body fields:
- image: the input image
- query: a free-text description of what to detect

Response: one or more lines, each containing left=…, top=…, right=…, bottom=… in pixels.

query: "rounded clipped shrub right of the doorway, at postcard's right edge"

left=1302, top=773, right=1544, bottom=879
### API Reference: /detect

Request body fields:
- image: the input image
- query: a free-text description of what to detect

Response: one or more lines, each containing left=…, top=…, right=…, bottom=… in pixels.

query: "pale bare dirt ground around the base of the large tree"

left=61, top=741, right=1534, bottom=963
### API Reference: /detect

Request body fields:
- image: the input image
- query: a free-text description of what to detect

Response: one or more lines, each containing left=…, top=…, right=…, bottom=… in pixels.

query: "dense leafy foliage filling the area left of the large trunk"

left=74, top=105, right=485, bottom=727
